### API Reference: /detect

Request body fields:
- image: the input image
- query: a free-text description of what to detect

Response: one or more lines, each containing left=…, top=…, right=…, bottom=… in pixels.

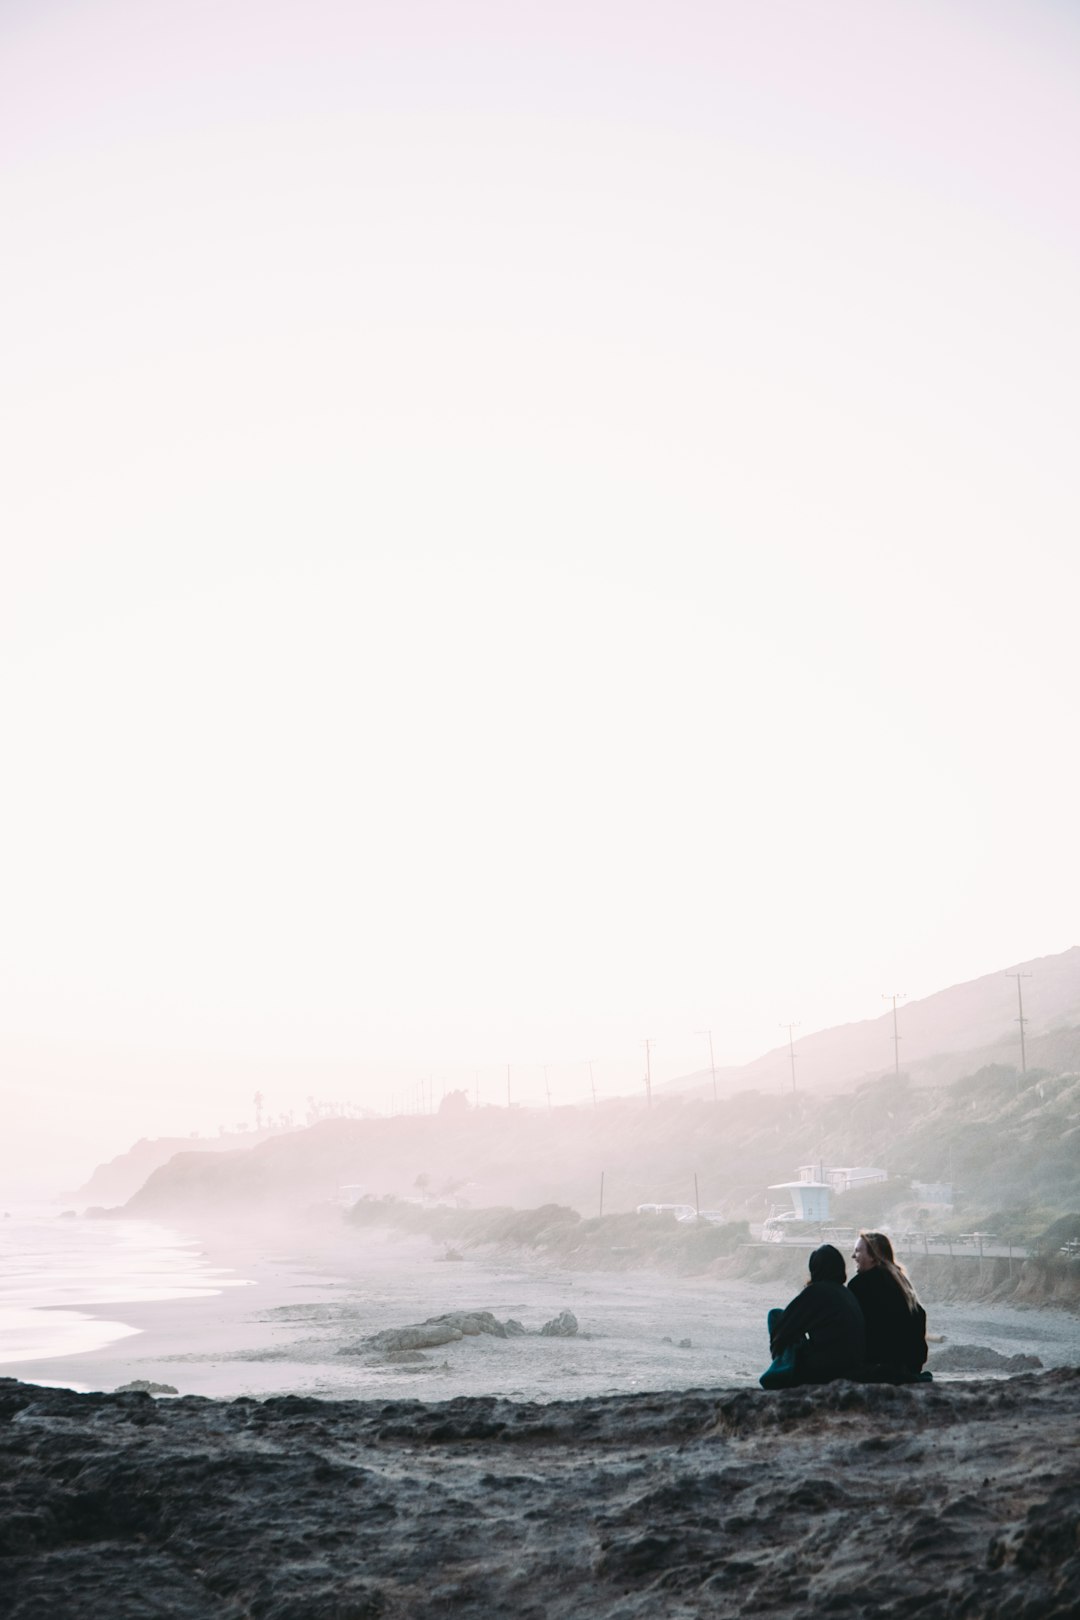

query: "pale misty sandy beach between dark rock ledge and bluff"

left=10, top=1220, right=1080, bottom=1401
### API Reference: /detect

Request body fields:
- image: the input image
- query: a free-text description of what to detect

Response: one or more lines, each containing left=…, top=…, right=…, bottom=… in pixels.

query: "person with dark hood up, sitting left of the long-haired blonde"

left=758, top=1243, right=866, bottom=1390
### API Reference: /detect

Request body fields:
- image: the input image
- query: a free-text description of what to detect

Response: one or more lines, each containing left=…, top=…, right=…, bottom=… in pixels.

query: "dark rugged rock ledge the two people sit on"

left=0, top=1369, right=1080, bottom=1620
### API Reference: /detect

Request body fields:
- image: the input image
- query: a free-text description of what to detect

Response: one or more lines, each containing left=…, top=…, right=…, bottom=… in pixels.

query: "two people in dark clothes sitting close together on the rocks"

left=759, top=1231, right=929, bottom=1390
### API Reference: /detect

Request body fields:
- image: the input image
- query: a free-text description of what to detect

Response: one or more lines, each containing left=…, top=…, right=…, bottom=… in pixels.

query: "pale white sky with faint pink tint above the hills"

left=0, top=0, right=1080, bottom=1173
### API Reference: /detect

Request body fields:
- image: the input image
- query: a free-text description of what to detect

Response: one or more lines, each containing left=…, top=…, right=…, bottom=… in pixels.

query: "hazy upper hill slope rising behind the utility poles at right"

left=664, top=946, right=1080, bottom=1095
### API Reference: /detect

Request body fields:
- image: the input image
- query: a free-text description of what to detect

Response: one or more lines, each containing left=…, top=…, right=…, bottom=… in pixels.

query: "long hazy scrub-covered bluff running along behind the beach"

left=126, top=1064, right=1080, bottom=1243
